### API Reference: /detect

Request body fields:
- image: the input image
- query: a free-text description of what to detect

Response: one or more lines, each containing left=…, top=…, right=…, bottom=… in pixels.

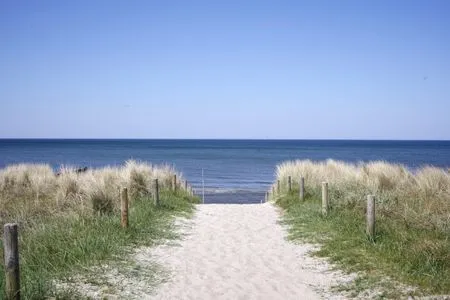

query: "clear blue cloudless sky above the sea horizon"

left=0, top=0, right=450, bottom=139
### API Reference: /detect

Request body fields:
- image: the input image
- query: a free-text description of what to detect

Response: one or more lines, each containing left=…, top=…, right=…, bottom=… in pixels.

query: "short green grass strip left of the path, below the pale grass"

left=0, top=191, right=198, bottom=299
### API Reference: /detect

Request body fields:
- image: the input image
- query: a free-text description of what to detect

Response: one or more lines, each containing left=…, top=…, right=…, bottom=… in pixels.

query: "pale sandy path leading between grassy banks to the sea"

left=142, top=204, right=354, bottom=299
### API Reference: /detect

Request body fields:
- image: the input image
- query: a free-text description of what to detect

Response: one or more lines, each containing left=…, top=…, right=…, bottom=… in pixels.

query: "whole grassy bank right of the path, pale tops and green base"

left=273, top=161, right=450, bottom=298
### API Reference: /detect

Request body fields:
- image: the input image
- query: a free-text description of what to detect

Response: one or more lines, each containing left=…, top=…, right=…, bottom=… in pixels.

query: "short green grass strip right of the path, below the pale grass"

left=276, top=192, right=450, bottom=298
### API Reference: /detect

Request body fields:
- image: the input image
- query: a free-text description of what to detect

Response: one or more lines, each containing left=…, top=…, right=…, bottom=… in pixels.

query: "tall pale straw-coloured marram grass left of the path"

left=0, top=160, right=184, bottom=225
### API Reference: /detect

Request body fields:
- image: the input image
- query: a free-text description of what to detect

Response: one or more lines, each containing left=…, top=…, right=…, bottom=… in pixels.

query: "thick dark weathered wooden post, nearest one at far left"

left=3, top=223, right=20, bottom=300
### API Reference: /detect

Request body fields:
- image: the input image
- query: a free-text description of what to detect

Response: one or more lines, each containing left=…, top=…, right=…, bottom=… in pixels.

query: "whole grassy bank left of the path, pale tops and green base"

left=0, top=162, right=198, bottom=299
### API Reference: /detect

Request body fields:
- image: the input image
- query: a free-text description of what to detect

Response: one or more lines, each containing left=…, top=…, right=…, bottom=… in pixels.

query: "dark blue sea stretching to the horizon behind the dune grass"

left=0, top=139, right=450, bottom=204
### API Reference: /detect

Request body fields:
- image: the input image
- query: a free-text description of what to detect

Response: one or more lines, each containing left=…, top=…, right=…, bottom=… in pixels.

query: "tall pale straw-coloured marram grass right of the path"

left=276, top=160, right=450, bottom=233
